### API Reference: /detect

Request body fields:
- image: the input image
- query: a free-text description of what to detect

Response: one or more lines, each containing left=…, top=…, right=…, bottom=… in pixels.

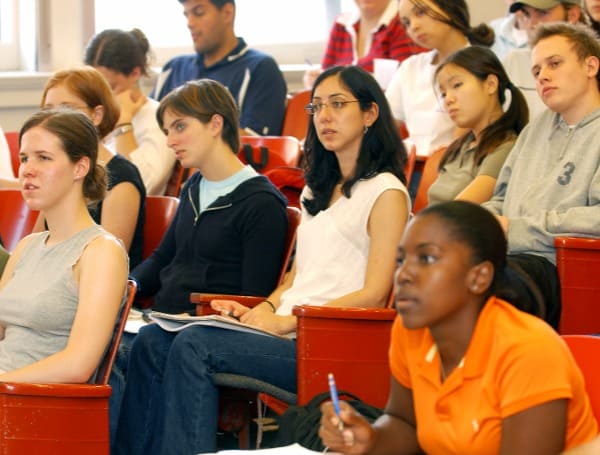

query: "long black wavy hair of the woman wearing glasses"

left=302, top=66, right=407, bottom=215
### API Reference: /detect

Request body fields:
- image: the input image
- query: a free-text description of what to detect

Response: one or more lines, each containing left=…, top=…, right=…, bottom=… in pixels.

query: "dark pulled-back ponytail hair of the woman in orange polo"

left=416, top=200, right=546, bottom=318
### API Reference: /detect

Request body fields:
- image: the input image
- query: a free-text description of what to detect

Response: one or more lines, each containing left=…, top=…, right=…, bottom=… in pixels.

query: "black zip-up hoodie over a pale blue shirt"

left=131, top=173, right=287, bottom=313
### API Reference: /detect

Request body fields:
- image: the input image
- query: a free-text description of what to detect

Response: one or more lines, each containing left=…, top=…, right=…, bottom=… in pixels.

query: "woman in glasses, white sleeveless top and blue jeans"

left=117, top=66, right=410, bottom=455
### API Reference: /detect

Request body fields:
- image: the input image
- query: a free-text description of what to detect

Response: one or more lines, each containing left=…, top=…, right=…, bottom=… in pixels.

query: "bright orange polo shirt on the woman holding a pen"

left=389, top=297, right=598, bottom=455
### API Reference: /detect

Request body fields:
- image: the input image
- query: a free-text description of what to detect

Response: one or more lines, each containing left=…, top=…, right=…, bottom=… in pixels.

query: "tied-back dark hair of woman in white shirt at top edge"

left=410, top=0, right=494, bottom=46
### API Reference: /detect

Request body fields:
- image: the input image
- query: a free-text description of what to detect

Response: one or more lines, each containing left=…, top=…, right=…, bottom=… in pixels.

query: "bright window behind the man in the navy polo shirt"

left=94, top=0, right=355, bottom=65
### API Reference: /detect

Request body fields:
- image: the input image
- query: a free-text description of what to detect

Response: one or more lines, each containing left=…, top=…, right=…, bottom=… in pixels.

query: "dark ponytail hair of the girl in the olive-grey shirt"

left=434, top=46, right=529, bottom=170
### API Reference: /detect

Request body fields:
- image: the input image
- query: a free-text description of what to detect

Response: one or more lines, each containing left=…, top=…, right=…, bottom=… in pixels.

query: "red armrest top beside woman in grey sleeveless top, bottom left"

left=0, top=382, right=111, bottom=398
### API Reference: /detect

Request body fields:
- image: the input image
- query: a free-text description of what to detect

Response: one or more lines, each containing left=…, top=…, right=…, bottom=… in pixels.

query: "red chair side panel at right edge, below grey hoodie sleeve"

left=554, top=237, right=600, bottom=335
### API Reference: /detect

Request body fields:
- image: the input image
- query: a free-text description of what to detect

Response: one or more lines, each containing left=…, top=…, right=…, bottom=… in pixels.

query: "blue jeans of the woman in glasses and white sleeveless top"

left=115, top=324, right=296, bottom=455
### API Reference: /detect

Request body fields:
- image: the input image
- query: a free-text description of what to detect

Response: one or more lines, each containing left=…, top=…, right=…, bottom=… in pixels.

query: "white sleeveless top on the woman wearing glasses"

left=277, top=172, right=410, bottom=316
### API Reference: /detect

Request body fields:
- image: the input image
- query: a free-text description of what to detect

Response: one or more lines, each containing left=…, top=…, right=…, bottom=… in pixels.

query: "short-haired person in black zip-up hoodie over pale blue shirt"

left=110, top=79, right=287, bottom=446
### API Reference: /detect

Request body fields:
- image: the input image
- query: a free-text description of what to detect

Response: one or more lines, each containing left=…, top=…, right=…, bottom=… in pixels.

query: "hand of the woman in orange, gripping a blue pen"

left=319, top=401, right=376, bottom=455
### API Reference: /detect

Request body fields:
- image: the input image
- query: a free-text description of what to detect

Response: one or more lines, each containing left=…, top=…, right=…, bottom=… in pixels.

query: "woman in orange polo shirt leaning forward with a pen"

left=319, top=201, right=598, bottom=455
